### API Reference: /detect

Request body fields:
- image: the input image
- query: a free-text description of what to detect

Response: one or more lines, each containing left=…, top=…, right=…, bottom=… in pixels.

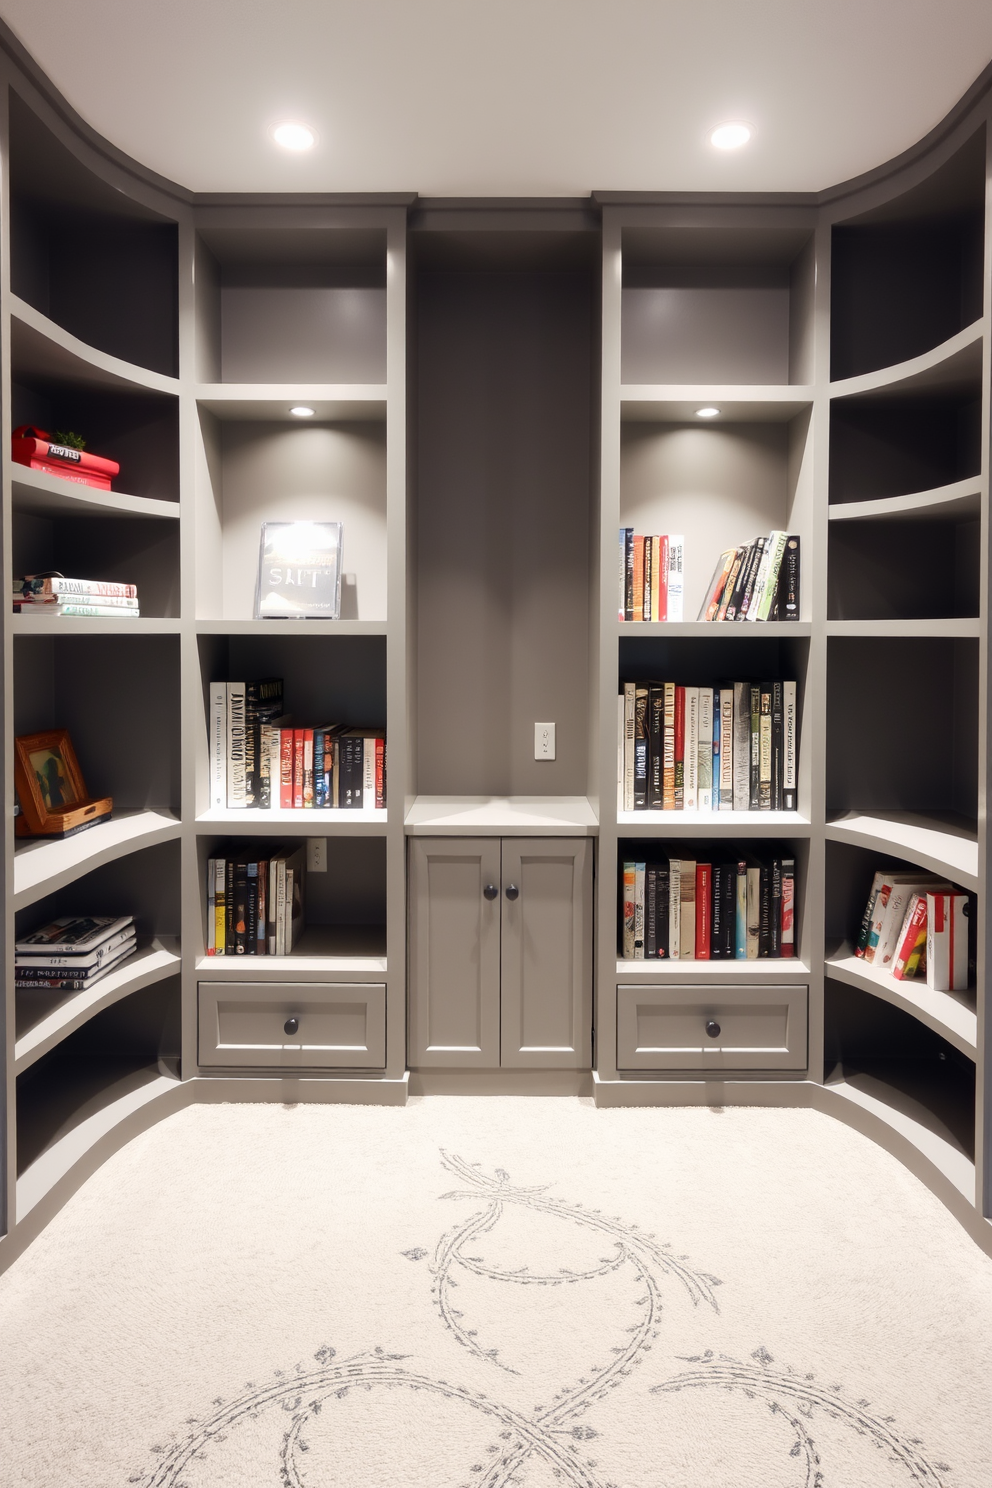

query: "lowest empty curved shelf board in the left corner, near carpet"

left=16, top=1061, right=185, bottom=1223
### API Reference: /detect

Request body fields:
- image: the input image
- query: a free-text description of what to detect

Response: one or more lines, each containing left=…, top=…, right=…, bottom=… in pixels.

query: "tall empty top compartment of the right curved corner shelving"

left=830, top=126, right=985, bottom=381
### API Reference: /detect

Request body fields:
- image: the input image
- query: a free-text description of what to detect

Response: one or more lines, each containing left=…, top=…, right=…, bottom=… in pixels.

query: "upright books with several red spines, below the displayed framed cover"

left=210, top=677, right=385, bottom=811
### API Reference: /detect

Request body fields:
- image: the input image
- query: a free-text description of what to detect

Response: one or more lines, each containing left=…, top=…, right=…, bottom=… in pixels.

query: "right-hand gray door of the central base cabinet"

left=500, top=838, right=592, bottom=1070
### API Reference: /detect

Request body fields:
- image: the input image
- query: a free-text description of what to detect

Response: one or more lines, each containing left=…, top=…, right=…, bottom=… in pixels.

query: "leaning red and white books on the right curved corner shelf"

left=854, top=869, right=973, bottom=992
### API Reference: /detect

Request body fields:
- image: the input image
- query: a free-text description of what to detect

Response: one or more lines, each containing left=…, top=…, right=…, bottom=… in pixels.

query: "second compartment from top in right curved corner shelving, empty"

left=830, top=377, right=982, bottom=503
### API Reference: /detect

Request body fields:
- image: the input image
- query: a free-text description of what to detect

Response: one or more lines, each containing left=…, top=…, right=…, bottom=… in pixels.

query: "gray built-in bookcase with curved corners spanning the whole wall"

left=0, top=33, right=992, bottom=1263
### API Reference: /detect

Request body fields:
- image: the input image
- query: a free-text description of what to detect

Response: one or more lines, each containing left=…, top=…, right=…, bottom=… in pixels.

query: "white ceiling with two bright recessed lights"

left=0, top=0, right=992, bottom=196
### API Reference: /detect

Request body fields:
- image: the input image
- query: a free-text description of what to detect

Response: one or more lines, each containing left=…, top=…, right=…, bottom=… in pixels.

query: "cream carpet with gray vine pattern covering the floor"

left=0, top=1098, right=992, bottom=1488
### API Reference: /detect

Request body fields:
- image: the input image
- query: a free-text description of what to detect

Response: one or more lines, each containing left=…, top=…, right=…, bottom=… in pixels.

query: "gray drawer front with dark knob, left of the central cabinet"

left=199, top=982, right=385, bottom=1070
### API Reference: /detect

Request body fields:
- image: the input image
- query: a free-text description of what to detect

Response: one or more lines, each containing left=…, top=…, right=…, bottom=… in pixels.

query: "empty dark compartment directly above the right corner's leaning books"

left=827, top=637, right=979, bottom=823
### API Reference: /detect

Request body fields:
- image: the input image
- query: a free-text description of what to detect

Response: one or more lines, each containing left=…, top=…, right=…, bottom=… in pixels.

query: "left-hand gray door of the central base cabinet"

left=409, top=838, right=501, bottom=1070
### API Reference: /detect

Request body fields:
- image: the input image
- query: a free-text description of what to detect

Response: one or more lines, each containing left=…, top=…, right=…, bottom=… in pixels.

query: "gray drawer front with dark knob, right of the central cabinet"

left=617, top=987, right=808, bottom=1071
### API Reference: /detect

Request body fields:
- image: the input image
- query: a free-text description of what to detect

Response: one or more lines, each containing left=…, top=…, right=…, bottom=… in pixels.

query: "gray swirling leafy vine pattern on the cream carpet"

left=136, top=1152, right=950, bottom=1488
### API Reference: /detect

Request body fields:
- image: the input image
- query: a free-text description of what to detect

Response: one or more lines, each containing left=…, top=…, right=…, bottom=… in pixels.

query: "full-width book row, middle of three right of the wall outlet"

left=617, top=680, right=799, bottom=811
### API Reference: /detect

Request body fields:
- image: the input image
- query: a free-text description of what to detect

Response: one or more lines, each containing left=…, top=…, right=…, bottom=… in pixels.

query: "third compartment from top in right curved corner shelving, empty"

left=827, top=516, right=982, bottom=620
